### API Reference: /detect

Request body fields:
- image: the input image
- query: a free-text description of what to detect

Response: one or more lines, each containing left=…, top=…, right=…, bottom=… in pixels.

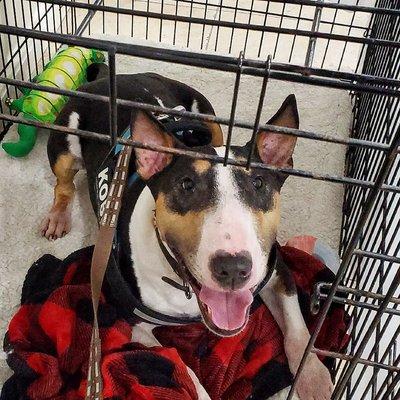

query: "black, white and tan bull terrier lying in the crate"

left=41, top=74, right=332, bottom=400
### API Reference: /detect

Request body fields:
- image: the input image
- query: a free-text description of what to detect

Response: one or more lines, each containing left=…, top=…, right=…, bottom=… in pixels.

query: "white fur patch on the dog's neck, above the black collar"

left=129, top=186, right=199, bottom=317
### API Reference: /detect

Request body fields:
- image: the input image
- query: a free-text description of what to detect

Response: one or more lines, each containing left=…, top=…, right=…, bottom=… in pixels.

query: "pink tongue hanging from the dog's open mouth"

left=199, top=286, right=253, bottom=331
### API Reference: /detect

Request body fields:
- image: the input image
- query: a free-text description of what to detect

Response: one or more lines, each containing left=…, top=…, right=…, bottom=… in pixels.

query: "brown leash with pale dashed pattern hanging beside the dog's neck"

left=85, top=137, right=132, bottom=400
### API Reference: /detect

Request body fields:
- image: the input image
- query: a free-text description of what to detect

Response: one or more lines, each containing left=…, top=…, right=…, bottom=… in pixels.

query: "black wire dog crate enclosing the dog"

left=0, top=0, right=400, bottom=400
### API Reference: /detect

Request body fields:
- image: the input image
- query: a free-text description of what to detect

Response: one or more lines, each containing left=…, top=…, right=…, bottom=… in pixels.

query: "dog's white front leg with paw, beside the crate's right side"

left=260, top=263, right=333, bottom=400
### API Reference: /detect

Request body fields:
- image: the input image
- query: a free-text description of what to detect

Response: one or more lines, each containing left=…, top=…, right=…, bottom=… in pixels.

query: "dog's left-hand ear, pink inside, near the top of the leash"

left=131, top=110, right=174, bottom=180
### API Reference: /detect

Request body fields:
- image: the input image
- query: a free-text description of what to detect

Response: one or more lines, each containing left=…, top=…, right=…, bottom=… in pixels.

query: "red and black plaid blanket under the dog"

left=1, top=247, right=347, bottom=400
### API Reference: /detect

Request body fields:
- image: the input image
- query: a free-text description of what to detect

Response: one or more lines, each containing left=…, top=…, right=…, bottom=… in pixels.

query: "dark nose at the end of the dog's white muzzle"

left=210, top=251, right=252, bottom=290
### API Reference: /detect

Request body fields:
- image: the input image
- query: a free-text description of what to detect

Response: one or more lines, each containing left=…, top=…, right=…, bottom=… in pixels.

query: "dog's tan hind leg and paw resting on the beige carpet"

left=40, top=152, right=78, bottom=240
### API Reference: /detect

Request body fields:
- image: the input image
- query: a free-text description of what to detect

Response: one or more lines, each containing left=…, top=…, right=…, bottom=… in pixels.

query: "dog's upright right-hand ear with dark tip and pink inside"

left=256, top=94, right=299, bottom=167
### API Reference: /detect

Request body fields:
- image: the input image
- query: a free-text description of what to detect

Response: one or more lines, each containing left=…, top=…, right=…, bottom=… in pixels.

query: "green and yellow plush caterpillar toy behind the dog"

left=2, top=46, right=105, bottom=157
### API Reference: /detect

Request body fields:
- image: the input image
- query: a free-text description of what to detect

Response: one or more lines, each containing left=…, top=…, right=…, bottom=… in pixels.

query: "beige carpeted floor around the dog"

left=0, top=0, right=354, bottom=390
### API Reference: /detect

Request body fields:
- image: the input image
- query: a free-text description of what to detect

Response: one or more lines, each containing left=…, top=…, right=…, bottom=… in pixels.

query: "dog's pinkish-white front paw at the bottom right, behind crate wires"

left=296, top=354, right=333, bottom=400
